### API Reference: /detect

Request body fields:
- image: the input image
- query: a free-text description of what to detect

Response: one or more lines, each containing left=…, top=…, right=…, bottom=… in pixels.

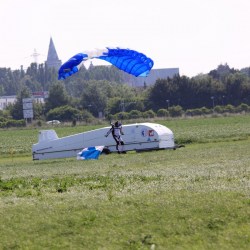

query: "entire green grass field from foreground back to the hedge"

left=0, top=115, right=250, bottom=249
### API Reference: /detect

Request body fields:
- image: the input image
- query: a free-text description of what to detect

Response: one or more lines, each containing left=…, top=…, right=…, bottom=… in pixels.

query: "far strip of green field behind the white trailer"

left=0, top=115, right=250, bottom=157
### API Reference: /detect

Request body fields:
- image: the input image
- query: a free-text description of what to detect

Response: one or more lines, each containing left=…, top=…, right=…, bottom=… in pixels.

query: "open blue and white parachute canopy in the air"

left=58, top=48, right=154, bottom=80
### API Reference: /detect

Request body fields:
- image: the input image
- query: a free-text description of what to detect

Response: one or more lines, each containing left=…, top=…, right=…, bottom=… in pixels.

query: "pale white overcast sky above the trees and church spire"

left=0, top=0, right=250, bottom=77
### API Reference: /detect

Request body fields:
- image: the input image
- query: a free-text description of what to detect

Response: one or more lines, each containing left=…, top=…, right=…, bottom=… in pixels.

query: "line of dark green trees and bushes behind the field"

left=0, top=63, right=250, bottom=123
